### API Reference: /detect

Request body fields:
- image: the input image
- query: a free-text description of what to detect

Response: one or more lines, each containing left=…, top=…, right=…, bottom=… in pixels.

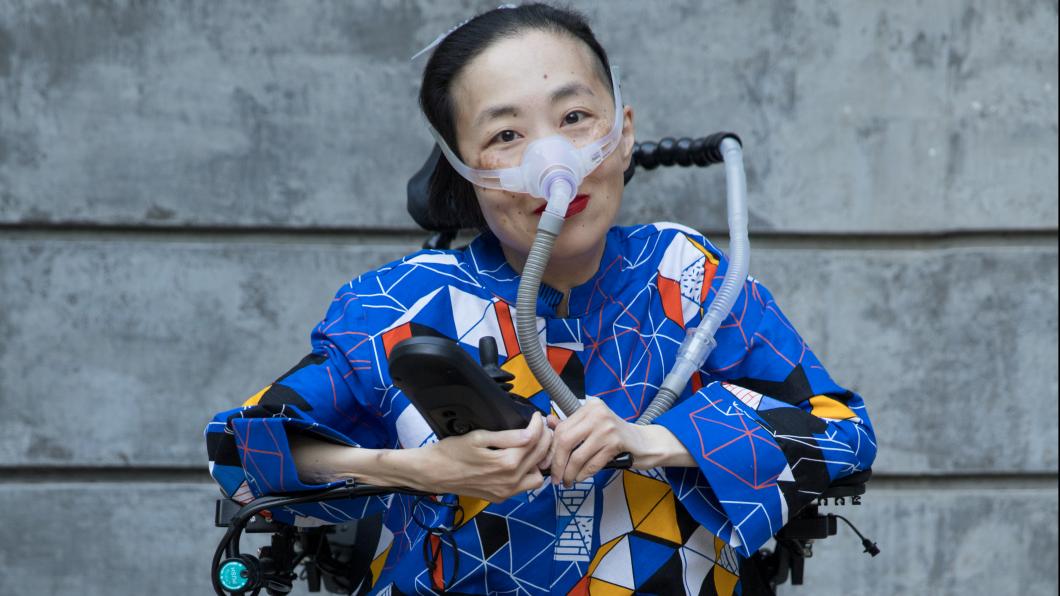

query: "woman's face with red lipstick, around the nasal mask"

left=451, top=31, right=634, bottom=265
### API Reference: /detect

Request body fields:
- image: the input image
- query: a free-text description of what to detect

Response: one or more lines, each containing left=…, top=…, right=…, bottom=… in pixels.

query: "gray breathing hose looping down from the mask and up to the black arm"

left=515, top=137, right=750, bottom=424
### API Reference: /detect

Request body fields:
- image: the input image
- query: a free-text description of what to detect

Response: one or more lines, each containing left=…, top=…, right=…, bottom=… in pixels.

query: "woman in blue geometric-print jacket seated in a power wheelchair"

left=200, top=4, right=876, bottom=594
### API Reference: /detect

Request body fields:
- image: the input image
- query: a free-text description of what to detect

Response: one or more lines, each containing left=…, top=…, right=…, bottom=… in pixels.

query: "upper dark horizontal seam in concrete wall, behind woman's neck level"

left=0, top=223, right=1060, bottom=250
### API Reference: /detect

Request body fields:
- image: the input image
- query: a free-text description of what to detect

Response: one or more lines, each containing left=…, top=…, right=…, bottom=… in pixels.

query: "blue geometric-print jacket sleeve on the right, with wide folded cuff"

left=655, top=234, right=877, bottom=557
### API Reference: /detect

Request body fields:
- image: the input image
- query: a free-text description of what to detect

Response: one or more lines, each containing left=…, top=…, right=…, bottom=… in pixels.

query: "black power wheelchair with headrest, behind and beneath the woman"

left=211, top=133, right=880, bottom=596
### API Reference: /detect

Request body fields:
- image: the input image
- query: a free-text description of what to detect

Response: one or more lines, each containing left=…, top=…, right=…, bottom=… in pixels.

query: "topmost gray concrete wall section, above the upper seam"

left=0, top=0, right=1058, bottom=232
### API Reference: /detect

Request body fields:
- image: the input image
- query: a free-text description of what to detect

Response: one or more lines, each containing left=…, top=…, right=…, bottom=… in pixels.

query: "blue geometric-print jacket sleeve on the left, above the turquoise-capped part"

left=205, top=284, right=389, bottom=523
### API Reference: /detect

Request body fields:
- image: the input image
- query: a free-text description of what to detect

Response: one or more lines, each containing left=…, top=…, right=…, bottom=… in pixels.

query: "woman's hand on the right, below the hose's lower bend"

left=548, top=398, right=695, bottom=487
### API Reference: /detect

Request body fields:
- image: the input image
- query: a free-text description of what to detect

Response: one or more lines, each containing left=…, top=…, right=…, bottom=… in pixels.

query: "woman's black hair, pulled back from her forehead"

left=420, top=2, right=612, bottom=230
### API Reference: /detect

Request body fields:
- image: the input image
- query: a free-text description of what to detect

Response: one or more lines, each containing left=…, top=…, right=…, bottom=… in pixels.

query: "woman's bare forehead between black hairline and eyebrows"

left=452, top=31, right=611, bottom=124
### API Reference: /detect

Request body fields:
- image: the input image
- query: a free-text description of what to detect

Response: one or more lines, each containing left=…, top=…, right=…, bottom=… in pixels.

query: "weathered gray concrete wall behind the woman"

left=0, top=0, right=1058, bottom=596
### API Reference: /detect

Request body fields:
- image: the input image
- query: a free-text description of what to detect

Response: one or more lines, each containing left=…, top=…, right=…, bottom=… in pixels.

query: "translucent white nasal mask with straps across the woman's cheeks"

left=427, top=67, right=623, bottom=228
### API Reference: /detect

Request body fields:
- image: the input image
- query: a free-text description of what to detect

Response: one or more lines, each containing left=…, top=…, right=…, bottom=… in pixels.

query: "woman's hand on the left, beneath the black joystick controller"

left=401, top=413, right=552, bottom=503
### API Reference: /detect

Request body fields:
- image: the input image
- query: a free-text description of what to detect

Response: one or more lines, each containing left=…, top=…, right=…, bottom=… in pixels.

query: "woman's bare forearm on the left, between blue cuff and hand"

left=288, top=436, right=427, bottom=490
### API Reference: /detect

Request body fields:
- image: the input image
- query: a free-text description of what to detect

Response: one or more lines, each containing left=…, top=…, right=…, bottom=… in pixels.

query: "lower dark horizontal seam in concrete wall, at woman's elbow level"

left=0, top=464, right=1060, bottom=489
